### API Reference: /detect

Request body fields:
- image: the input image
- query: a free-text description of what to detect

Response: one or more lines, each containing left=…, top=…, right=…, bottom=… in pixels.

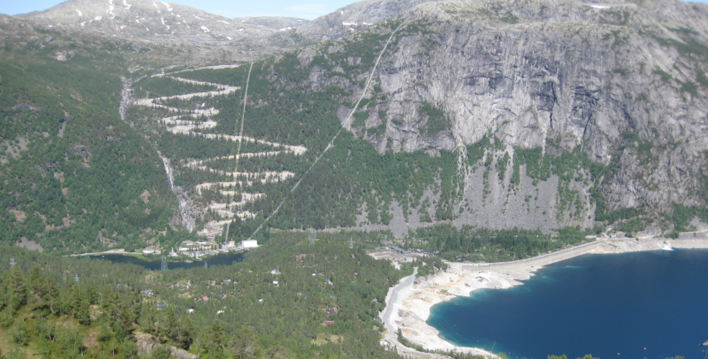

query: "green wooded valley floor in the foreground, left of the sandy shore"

left=0, top=232, right=410, bottom=359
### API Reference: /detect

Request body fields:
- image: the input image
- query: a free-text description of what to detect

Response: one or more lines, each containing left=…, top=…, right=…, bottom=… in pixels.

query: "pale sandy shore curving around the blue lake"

left=381, top=235, right=708, bottom=358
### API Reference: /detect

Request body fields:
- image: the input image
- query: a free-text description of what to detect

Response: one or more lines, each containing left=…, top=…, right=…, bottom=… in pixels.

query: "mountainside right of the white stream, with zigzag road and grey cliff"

left=123, top=1, right=708, bottom=250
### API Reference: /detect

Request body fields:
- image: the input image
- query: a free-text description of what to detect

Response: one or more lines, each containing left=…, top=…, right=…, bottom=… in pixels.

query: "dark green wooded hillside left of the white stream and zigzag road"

left=0, top=21, right=176, bottom=252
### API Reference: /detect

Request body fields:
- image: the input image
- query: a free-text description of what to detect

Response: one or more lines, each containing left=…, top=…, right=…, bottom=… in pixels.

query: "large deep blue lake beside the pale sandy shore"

left=428, top=249, right=708, bottom=359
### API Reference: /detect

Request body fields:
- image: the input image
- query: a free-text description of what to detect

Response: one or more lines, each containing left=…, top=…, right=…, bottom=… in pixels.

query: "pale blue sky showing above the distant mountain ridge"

left=0, top=0, right=708, bottom=20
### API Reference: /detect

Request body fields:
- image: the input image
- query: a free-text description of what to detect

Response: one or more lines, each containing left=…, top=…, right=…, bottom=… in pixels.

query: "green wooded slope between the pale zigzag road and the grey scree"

left=140, top=54, right=470, bottom=239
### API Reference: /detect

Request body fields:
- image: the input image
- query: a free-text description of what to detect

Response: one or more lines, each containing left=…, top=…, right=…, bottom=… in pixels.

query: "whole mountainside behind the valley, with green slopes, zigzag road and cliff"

left=0, top=0, right=708, bottom=258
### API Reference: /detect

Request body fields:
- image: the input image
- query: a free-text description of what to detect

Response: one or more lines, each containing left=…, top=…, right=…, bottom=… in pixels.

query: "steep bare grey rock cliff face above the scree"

left=294, top=1, right=708, bottom=231
